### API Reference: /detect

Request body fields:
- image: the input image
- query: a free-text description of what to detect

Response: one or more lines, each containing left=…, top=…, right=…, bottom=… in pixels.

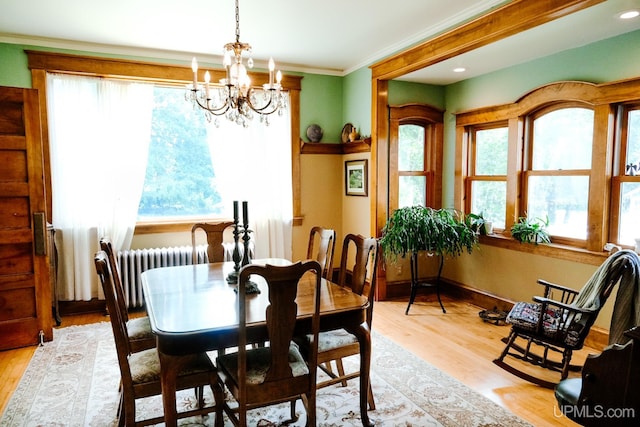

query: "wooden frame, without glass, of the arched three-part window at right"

left=454, top=78, right=640, bottom=264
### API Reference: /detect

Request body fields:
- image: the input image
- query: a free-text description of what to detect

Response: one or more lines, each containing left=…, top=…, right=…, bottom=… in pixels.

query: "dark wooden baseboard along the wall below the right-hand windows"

left=387, top=279, right=609, bottom=350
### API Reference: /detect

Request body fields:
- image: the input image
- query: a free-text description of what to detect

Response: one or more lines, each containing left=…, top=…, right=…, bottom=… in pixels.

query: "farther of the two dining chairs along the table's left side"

left=100, top=237, right=156, bottom=353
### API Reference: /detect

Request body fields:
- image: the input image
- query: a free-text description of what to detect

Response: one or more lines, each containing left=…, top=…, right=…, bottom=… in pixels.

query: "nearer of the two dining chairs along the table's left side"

left=94, top=251, right=224, bottom=426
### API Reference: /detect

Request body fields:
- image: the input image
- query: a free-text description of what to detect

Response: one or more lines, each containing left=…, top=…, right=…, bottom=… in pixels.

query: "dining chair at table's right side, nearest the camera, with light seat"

left=297, top=234, right=379, bottom=410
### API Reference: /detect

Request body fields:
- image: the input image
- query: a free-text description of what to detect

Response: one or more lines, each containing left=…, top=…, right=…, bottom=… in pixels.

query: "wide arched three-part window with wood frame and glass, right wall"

left=454, top=79, right=640, bottom=256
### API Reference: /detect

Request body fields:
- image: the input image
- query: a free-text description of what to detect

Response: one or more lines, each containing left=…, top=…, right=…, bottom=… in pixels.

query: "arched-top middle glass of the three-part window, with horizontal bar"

left=522, top=106, right=594, bottom=244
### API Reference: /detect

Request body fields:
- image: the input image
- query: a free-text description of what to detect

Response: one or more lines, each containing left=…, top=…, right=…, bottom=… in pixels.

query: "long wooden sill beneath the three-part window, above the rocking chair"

left=480, top=233, right=609, bottom=265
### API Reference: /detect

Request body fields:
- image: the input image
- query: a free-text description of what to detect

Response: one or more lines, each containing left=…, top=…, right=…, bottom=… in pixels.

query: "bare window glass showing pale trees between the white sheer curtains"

left=138, top=85, right=223, bottom=221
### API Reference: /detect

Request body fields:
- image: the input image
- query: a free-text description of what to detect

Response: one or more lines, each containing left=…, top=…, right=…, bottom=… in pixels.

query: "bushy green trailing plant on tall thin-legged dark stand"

left=380, top=206, right=478, bottom=314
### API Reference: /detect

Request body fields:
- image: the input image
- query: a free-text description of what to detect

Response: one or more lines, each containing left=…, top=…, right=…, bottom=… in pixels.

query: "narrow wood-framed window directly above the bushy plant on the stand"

left=389, top=104, right=442, bottom=210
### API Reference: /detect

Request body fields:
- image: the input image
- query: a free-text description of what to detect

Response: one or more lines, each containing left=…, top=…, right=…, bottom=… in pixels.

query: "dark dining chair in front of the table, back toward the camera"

left=217, top=260, right=322, bottom=427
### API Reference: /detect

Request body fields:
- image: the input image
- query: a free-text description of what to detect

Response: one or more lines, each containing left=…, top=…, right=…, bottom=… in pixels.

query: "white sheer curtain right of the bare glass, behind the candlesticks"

left=207, top=103, right=293, bottom=259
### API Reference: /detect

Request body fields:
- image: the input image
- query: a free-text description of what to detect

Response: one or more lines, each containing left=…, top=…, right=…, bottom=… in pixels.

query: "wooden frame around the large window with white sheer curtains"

left=25, top=50, right=302, bottom=234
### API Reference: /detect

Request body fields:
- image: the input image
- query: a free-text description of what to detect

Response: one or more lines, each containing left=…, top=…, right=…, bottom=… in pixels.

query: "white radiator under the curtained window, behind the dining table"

left=117, top=242, right=254, bottom=308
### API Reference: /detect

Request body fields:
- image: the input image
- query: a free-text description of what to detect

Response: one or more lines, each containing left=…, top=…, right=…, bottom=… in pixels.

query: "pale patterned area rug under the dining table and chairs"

left=0, top=322, right=529, bottom=427
